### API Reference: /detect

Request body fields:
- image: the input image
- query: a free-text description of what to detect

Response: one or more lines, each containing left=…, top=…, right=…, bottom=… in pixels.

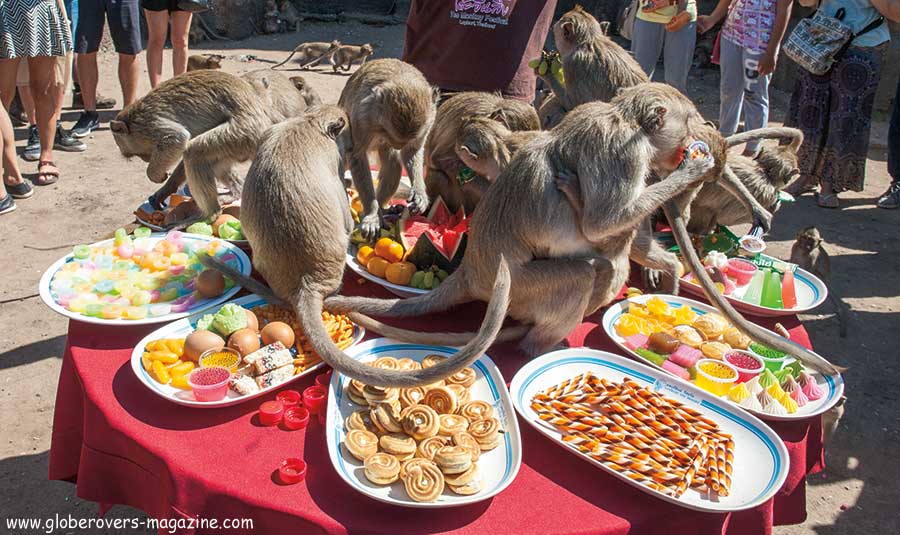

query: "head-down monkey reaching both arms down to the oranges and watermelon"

left=338, top=59, right=440, bottom=239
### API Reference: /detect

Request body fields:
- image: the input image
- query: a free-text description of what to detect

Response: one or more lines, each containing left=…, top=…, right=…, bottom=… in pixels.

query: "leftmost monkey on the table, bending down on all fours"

left=110, top=70, right=274, bottom=224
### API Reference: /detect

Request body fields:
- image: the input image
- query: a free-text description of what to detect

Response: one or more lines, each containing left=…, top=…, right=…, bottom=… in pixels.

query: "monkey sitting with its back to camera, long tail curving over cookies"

left=201, top=106, right=510, bottom=387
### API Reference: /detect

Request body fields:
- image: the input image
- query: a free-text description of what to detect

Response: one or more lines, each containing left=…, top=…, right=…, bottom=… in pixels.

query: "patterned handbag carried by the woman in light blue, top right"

left=784, top=8, right=884, bottom=76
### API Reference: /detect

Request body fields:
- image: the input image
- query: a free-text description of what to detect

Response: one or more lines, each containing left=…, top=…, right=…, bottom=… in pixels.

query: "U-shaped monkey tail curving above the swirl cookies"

left=296, top=257, right=511, bottom=388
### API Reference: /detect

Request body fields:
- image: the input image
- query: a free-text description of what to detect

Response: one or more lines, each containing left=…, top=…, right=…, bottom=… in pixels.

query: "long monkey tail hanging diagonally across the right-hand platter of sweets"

left=663, top=201, right=839, bottom=375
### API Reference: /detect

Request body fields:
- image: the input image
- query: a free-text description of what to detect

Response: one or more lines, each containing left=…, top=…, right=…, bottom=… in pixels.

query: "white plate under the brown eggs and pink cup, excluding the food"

left=131, top=295, right=366, bottom=409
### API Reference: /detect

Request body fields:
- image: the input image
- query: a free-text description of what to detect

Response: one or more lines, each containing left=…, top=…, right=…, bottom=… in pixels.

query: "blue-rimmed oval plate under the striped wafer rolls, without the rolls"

left=510, top=348, right=789, bottom=513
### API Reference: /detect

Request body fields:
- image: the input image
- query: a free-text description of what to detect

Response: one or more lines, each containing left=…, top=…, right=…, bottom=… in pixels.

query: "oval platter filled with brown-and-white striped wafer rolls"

left=509, top=348, right=790, bottom=513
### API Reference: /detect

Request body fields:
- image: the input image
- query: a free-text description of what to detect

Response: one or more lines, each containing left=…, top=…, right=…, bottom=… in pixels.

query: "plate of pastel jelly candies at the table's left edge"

left=39, top=228, right=251, bottom=325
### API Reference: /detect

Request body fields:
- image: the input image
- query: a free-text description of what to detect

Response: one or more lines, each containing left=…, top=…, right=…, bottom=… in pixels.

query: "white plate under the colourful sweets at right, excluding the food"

left=603, top=294, right=844, bottom=420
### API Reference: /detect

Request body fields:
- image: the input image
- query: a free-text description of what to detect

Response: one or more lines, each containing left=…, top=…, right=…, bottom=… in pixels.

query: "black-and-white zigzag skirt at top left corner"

left=0, top=0, right=72, bottom=59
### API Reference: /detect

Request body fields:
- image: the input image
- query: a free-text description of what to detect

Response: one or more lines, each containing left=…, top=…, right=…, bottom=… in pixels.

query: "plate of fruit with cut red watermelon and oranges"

left=347, top=198, right=469, bottom=297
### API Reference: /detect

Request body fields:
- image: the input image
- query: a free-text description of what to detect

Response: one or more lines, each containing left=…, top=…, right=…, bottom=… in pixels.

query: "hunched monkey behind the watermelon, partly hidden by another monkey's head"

left=425, top=92, right=540, bottom=214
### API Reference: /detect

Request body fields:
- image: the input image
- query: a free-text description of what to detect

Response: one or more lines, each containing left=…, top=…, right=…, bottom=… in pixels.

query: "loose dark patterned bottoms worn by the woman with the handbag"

left=784, top=45, right=887, bottom=192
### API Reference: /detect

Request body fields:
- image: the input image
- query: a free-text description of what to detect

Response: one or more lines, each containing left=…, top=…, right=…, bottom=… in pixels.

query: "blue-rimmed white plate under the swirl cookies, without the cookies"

left=325, top=338, right=522, bottom=508
